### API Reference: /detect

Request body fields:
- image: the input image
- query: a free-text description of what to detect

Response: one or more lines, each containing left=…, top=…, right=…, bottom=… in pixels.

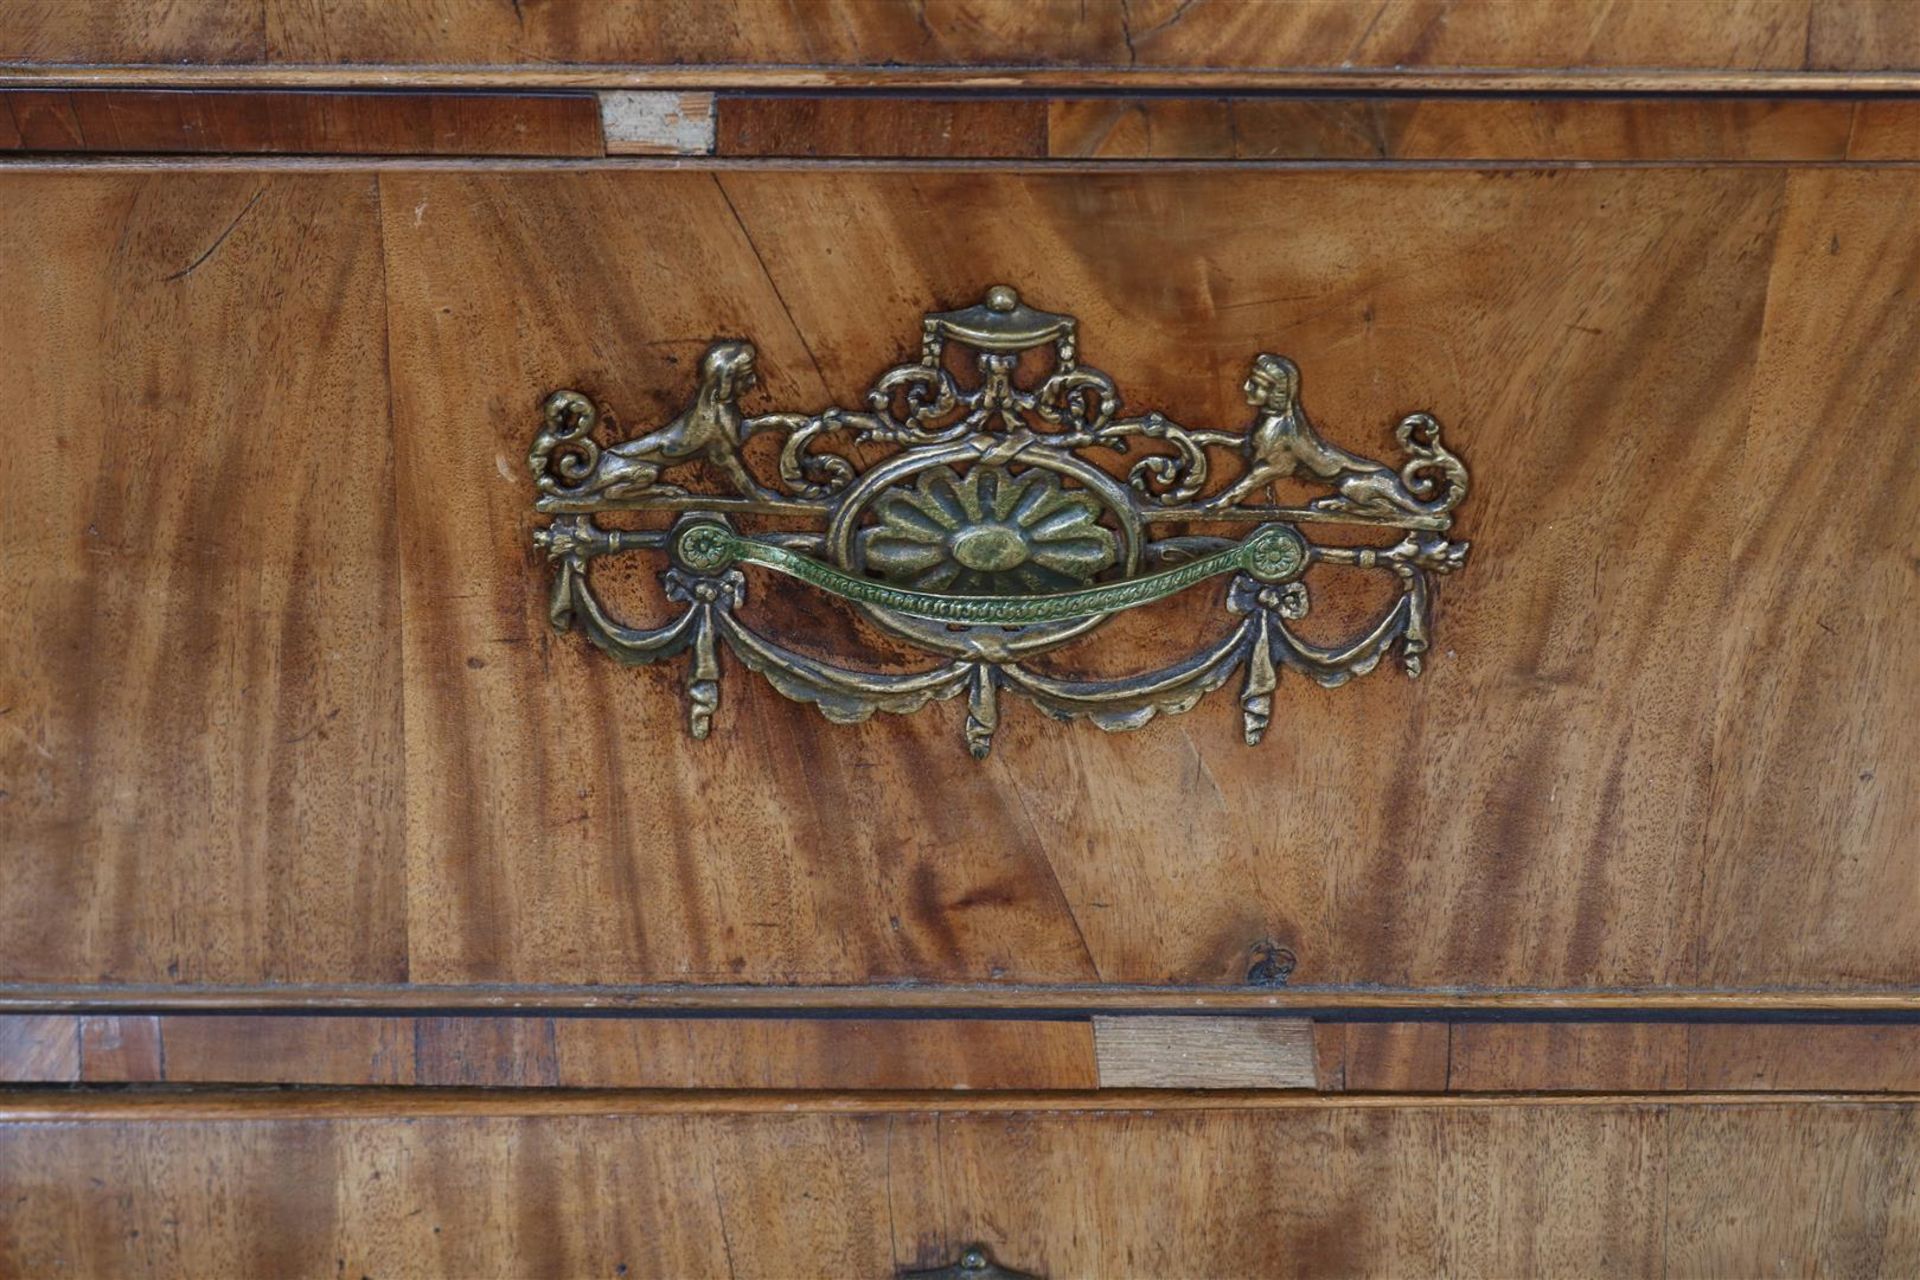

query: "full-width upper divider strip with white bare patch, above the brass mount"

left=0, top=88, right=1920, bottom=163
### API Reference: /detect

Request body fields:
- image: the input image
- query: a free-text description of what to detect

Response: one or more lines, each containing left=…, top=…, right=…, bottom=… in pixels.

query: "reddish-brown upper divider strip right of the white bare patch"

left=706, top=92, right=1920, bottom=163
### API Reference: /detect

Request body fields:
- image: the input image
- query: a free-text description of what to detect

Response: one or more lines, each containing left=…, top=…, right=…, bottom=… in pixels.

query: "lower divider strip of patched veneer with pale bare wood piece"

left=11, top=1013, right=1920, bottom=1094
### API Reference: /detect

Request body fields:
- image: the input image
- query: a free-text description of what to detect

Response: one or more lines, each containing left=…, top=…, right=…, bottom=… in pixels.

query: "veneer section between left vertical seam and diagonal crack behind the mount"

left=382, top=175, right=1121, bottom=983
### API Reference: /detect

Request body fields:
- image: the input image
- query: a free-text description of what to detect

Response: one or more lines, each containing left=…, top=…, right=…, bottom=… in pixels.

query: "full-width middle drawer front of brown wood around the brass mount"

left=0, top=167, right=1920, bottom=990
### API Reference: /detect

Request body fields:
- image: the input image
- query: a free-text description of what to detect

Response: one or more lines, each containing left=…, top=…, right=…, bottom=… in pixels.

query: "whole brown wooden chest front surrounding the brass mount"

left=0, top=0, right=1920, bottom=1278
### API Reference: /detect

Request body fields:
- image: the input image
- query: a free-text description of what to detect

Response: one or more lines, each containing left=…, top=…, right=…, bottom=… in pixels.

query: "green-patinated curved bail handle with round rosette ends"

left=674, top=522, right=1308, bottom=628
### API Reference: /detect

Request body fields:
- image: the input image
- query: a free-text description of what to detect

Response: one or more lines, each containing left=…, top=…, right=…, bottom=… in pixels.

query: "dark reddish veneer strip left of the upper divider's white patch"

left=0, top=88, right=605, bottom=155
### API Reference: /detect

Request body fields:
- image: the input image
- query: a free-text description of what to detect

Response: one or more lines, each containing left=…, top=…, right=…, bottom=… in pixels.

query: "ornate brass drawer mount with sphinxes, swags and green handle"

left=528, top=286, right=1467, bottom=758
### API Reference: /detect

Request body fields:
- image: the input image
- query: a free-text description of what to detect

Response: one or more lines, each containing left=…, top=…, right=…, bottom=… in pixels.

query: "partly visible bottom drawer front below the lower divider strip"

left=0, top=1100, right=1920, bottom=1276
